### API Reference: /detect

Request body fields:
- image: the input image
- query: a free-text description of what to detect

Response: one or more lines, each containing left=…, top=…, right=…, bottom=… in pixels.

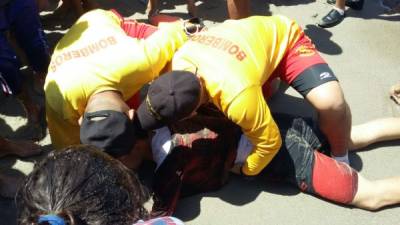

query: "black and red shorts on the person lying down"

left=263, top=114, right=358, bottom=204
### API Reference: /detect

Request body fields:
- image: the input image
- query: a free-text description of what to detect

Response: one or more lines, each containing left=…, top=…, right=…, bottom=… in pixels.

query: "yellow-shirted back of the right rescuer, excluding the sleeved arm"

left=172, top=16, right=302, bottom=101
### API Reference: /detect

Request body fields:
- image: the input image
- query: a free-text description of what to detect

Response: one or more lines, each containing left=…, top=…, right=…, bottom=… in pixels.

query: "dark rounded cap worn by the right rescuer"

left=137, top=71, right=201, bottom=130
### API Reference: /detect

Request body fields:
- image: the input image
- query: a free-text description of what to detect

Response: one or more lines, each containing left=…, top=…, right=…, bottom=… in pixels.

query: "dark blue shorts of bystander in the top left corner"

left=0, top=0, right=50, bottom=94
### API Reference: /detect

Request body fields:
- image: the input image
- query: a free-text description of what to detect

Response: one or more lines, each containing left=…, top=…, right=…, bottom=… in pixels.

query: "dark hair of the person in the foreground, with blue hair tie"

left=16, top=145, right=149, bottom=225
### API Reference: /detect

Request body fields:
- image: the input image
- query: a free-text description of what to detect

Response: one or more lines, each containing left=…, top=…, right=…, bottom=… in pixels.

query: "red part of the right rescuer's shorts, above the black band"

left=263, top=33, right=326, bottom=85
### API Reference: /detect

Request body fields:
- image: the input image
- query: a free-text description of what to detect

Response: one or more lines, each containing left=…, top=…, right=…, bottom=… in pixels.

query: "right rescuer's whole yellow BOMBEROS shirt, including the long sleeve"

left=172, top=16, right=302, bottom=175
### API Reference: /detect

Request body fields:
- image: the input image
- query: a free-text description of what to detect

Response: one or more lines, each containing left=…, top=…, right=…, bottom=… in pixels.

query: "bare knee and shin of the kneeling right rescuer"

left=306, top=81, right=351, bottom=156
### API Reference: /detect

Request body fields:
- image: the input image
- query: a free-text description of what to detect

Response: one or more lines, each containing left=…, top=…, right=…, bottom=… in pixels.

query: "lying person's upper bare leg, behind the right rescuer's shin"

left=349, top=117, right=400, bottom=150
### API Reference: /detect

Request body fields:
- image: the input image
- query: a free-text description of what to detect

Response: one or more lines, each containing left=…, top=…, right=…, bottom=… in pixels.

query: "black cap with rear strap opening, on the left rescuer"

left=80, top=110, right=135, bottom=157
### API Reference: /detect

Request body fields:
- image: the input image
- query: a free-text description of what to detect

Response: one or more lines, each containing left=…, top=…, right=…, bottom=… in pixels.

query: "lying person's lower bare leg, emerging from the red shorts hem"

left=351, top=174, right=400, bottom=210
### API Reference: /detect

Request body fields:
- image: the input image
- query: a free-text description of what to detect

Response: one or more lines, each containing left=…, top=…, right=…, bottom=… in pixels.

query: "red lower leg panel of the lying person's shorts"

left=312, top=151, right=358, bottom=204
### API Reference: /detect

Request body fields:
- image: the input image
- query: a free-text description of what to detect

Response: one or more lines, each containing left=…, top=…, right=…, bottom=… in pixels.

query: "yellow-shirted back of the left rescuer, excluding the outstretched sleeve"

left=45, top=10, right=155, bottom=118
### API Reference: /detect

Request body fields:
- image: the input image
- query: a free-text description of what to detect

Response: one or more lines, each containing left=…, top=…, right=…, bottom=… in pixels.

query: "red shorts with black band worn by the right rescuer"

left=263, top=33, right=338, bottom=97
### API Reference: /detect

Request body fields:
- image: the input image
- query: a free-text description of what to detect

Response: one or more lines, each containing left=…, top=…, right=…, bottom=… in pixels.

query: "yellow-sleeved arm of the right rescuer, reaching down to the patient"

left=227, top=87, right=282, bottom=175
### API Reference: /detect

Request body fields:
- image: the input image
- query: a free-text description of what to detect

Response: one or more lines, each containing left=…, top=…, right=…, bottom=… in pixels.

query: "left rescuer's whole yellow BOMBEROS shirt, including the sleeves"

left=45, top=9, right=187, bottom=147
